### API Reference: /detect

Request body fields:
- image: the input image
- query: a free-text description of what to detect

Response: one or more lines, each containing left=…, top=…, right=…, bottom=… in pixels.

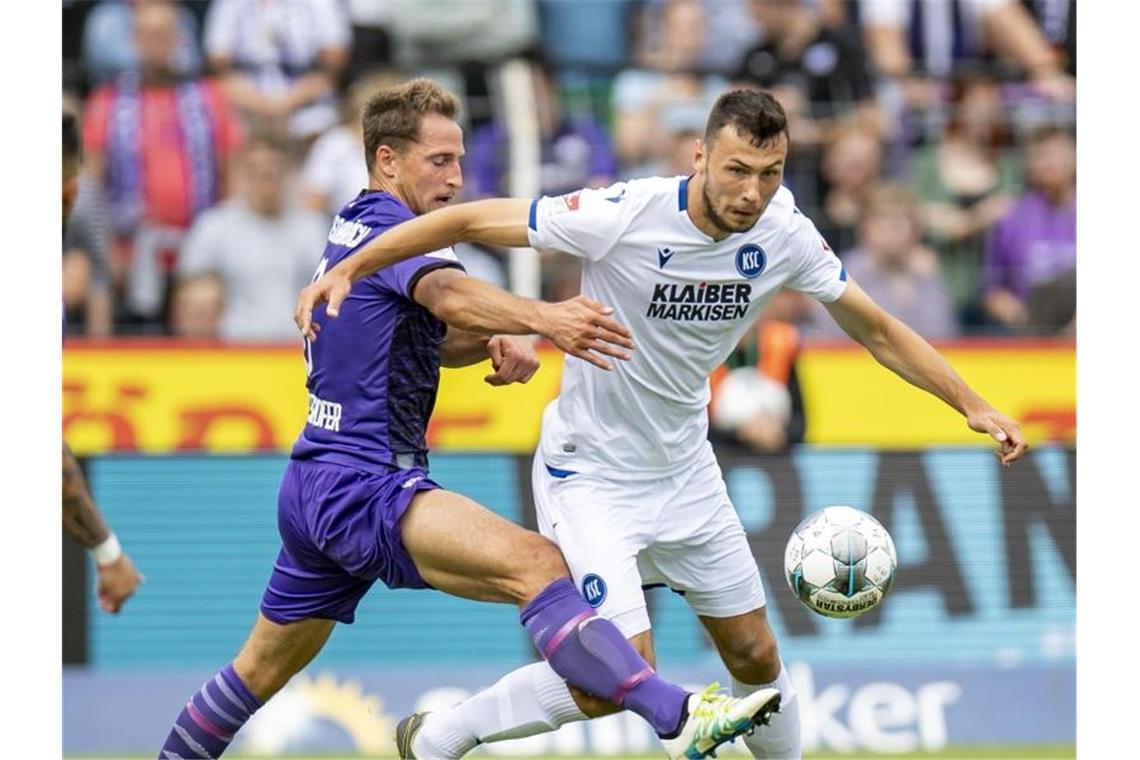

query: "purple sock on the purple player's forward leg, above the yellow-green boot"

left=520, top=578, right=689, bottom=736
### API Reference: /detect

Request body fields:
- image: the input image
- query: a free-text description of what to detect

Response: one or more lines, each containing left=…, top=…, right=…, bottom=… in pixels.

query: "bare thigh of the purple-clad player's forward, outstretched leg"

left=400, top=489, right=570, bottom=606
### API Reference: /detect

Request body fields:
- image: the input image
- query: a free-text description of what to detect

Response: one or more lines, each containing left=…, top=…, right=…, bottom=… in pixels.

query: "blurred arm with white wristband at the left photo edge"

left=63, top=442, right=143, bottom=613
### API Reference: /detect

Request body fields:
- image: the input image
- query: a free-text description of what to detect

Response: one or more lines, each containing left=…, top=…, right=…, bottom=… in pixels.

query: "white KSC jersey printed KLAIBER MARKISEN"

left=529, top=177, right=847, bottom=477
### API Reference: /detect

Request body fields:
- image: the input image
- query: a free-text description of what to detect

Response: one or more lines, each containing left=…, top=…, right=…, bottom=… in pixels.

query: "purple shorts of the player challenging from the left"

left=261, top=459, right=439, bottom=623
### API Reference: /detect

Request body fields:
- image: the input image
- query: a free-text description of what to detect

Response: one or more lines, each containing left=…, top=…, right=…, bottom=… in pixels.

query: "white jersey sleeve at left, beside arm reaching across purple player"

left=527, top=182, right=633, bottom=261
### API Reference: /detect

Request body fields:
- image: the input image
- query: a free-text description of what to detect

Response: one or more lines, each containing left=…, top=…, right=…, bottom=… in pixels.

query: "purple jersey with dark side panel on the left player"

left=292, top=190, right=462, bottom=469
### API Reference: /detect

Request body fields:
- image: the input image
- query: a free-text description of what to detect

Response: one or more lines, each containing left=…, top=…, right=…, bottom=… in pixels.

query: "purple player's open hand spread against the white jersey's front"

left=540, top=295, right=634, bottom=369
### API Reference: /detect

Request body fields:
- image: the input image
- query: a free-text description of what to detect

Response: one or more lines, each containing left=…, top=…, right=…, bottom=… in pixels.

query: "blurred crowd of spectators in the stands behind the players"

left=63, top=0, right=1076, bottom=341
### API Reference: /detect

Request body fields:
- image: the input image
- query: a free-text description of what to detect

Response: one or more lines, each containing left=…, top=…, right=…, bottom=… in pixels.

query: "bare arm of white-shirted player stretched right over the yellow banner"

left=824, top=280, right=1029, bottom=465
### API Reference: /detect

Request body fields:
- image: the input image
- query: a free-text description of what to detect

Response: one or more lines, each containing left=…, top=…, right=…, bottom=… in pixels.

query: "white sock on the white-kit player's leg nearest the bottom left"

left=414, top=661, right=587, bottom=759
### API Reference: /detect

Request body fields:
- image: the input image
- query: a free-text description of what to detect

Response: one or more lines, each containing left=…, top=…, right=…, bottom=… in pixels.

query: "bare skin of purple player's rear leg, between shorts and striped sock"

left=234, top=613, right=336, bottom=702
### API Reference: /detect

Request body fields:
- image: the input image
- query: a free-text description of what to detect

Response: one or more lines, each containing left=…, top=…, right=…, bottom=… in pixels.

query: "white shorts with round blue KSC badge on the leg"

left=532, top=448, right=765, bottom=638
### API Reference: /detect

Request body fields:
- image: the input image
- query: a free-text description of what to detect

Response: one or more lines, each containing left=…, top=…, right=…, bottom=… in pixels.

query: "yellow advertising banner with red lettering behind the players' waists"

left=63, top=342, right=1076, bottom=455
